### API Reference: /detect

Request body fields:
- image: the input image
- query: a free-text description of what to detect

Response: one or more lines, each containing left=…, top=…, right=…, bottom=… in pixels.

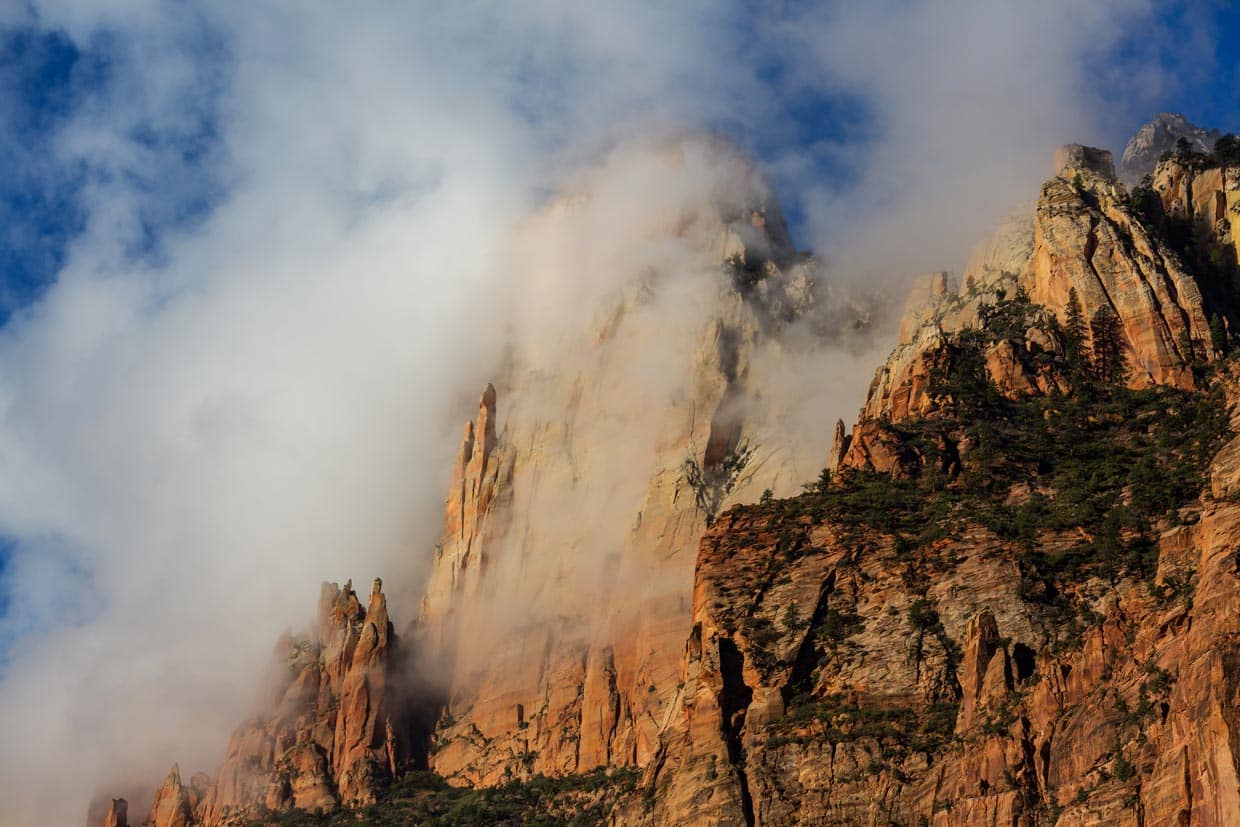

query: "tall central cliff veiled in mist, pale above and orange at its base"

left=420, top=137, right=872, bottom=785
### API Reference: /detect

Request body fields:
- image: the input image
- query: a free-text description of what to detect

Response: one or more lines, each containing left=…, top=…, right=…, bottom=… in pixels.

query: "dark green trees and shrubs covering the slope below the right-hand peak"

left=744, top=294, right=1229, bottom=625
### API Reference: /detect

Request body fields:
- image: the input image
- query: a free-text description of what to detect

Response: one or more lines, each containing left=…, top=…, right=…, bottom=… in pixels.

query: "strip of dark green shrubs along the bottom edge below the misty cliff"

left=249, top=770, right=637, bottom=827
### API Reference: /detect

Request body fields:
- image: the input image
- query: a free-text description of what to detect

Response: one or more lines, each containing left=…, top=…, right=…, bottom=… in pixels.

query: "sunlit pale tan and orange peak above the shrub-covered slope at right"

left=841, top=145, right=1214, bottom=470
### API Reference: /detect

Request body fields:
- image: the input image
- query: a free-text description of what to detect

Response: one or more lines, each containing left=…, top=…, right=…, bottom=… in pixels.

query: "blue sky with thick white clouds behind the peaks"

left=0, top=0, right=1240, bottom=823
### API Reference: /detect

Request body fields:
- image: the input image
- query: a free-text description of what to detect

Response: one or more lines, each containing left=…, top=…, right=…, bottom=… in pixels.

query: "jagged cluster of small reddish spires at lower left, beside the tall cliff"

left=146, top=580, right=408, bottom=827
